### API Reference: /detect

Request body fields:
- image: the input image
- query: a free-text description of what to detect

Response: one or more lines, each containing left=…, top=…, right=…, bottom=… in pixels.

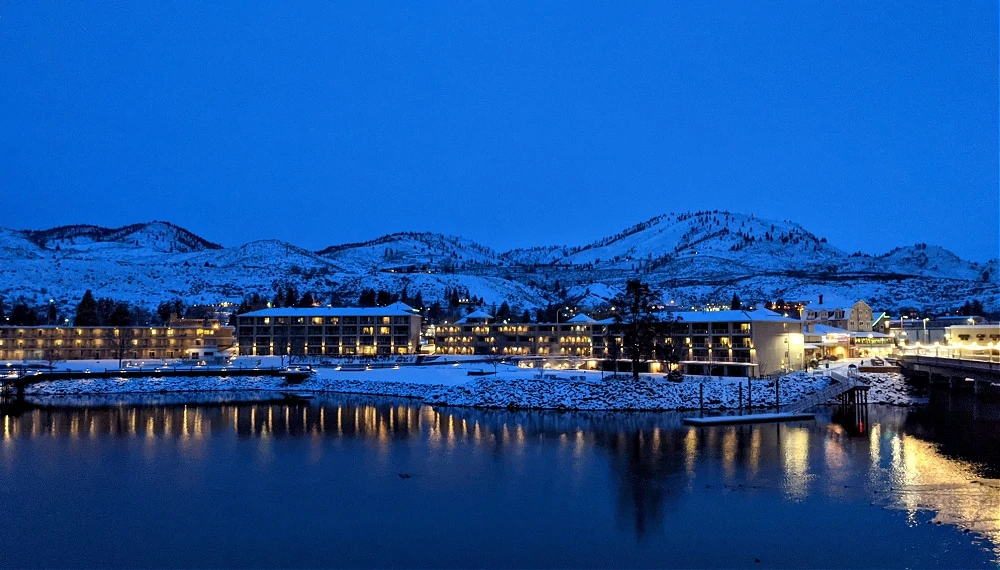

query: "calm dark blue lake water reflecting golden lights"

left=0, top=388, right=1000, bottom=567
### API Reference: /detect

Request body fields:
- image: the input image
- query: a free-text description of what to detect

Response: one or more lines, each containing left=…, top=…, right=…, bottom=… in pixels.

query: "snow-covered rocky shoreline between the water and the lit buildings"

left=13, top=356, right=922, bottom=411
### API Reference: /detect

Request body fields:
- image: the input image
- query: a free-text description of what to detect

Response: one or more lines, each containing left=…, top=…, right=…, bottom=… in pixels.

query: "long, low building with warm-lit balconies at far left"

left=0, top=321, right=234, bottom=361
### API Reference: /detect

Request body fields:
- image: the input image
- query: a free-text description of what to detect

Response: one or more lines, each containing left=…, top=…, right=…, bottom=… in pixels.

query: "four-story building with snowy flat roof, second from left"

left=236, top=303, right=420, bottom=356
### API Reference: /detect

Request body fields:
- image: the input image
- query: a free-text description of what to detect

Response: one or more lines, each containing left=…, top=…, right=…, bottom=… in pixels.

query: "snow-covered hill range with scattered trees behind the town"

left=0, top=211, right=1000, bottom=316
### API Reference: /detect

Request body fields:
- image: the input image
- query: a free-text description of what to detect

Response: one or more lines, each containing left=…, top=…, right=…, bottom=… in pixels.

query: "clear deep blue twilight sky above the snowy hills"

left=0, top=0, right=1000, bottom=260
